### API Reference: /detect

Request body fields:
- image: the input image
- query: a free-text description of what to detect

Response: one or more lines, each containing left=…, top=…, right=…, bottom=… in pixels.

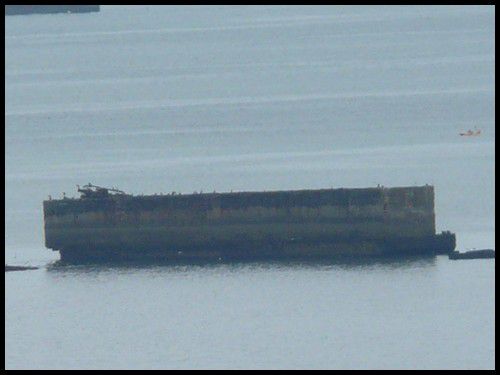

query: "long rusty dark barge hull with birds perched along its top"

left=43, top=185, right=455, bottom=262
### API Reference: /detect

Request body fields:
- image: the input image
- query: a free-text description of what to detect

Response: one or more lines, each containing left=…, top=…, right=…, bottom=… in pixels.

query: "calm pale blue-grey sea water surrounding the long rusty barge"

left=5, top=6, right=495, bottom=369
